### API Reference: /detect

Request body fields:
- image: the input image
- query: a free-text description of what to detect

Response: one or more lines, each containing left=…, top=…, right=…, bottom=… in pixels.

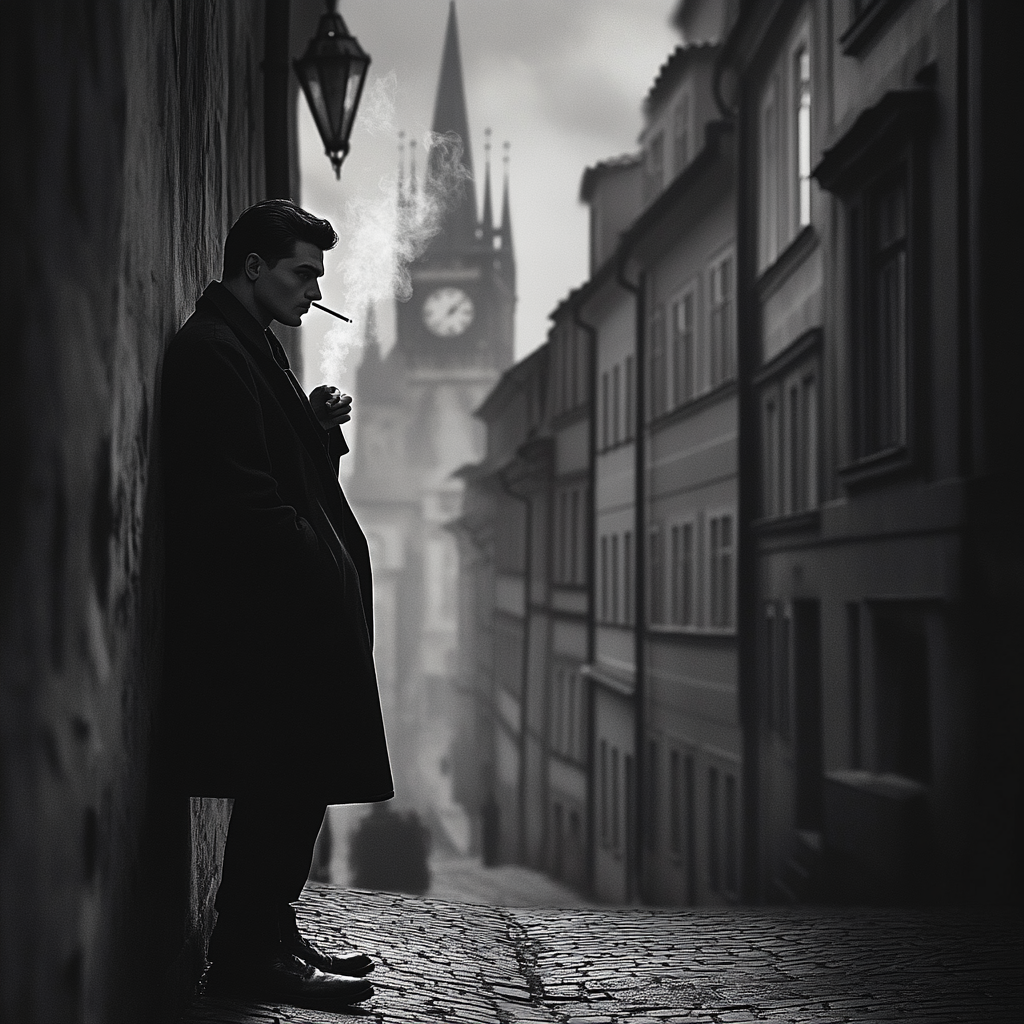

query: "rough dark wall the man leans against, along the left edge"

left=0, top=0, right=263, bottom=1022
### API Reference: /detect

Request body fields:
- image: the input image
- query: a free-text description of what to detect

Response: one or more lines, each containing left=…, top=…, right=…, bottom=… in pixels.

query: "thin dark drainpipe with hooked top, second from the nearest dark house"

left=615, top=258, right=647, bottom=898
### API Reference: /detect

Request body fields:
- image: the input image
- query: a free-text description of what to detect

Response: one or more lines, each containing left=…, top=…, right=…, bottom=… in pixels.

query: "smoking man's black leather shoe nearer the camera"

left=206, top=951, right=374, bottom=1010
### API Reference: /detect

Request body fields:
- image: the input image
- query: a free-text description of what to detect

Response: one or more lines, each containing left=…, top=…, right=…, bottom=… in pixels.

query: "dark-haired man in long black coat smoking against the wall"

left=162, top=200, right=394, bottom=1008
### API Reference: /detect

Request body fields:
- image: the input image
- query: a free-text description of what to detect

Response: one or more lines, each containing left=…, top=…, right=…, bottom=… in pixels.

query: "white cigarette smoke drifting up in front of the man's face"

left=321, top=128, right=471, bottom=380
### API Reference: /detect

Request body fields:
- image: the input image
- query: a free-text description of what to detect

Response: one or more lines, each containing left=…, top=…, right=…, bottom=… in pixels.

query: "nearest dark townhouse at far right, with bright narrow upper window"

left=725, top=0, right=1020, bottom=901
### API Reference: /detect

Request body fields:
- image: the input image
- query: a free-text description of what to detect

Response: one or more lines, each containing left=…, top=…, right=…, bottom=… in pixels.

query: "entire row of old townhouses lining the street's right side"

left=454, top=0, right=1024, bottom=904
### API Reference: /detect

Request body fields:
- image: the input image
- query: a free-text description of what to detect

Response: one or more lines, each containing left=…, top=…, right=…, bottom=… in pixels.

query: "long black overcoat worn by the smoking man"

left=162, top=283, right=394, bottom=803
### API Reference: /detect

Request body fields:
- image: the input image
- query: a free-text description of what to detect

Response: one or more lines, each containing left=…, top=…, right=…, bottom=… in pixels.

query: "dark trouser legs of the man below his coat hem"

left=210, top=793, right=327, bottom=963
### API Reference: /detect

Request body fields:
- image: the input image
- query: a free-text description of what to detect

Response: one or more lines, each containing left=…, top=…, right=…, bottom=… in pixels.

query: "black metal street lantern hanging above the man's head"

left=293, top=0, right=370, bottom=178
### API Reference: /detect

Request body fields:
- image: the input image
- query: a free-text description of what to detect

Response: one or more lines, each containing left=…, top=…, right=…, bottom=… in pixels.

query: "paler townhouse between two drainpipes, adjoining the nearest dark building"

left=622, top=42, right=742, bottom=904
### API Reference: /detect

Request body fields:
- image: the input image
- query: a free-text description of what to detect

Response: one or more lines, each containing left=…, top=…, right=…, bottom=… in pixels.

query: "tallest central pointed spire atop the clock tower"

left=427, top=0, right=476, bottom=248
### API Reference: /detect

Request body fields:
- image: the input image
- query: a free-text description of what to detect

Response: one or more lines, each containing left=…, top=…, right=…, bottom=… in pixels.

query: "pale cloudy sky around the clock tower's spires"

left=299, top=0, right=680, bottom=389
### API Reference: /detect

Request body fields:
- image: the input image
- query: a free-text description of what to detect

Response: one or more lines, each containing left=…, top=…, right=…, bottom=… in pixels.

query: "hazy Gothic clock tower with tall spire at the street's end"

left=345, top=0, right=515, bottom=846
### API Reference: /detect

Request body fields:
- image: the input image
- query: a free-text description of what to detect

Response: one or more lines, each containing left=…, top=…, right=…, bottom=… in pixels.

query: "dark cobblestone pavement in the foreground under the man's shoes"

left=181, top=886, right=1024, bottom=1024
